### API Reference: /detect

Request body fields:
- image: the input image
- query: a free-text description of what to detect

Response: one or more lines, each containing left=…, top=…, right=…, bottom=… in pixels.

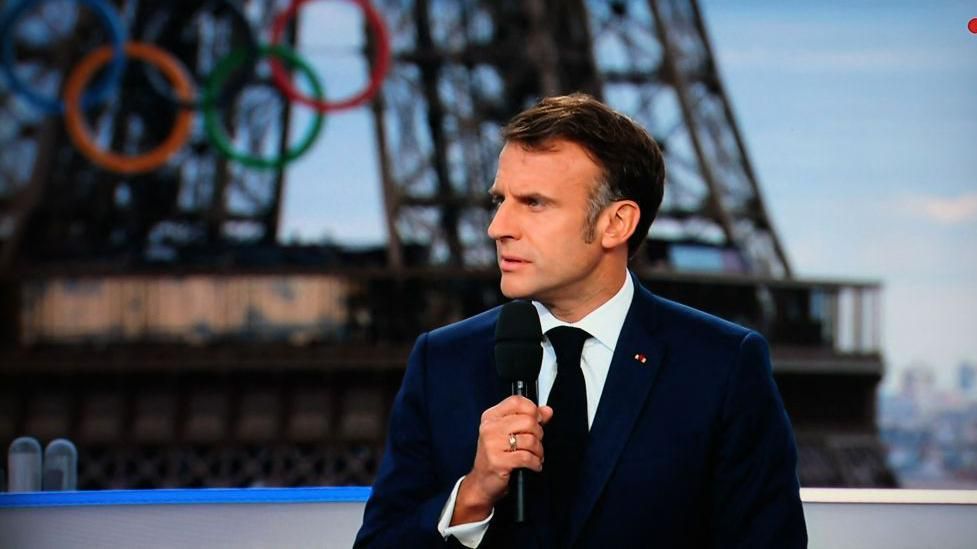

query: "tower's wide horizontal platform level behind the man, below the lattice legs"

left=0, top=269, right=892, bottom=488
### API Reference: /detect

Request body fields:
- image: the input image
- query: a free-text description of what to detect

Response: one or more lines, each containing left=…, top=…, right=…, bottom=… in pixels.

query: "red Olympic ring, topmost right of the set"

left=271, top=0, right=390, bottom=112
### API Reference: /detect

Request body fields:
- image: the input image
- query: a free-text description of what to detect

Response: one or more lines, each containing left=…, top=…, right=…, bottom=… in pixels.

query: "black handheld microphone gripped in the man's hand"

left=495, top=301, right=543, bottom=522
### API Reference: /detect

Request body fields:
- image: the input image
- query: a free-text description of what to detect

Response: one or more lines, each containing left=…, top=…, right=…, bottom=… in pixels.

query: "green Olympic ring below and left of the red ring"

left=203, top=45, right=325, bottom=169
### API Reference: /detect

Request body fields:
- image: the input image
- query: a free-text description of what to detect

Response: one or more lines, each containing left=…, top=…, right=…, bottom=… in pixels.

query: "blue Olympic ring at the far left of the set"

left=0, top=0, right=126, bottom=114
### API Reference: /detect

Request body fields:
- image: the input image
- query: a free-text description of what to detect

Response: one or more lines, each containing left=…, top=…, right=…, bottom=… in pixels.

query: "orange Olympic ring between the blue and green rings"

left=64, top=42, right=193, bottom=174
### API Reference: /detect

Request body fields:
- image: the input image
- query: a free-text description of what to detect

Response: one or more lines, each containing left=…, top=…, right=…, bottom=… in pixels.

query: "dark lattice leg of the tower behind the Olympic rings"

left=0, top=0, right=288, bottom=269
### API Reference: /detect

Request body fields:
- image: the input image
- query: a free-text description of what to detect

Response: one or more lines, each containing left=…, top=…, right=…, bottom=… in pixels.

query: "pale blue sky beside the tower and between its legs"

left=280, top=0, right=977, bottom=387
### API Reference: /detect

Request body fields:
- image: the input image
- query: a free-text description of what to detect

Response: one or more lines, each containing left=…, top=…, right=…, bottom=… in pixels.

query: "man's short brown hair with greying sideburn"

left=502, top=93, right=665, bottom=256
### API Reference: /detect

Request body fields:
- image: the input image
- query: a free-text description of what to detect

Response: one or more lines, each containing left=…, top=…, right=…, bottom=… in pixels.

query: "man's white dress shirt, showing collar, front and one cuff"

left=438, top=274, right=634, bottom=547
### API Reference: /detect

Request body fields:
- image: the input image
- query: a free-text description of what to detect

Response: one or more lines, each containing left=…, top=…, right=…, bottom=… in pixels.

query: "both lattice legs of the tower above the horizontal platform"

left=0, top=0, right=789, bottom=276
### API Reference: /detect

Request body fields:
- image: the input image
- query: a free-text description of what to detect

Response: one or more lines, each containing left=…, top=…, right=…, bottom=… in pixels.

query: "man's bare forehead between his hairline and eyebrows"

left=493, top=139, right=601, bottom=191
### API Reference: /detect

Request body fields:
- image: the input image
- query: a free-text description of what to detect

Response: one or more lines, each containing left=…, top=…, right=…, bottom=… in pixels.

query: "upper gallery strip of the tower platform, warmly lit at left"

left=7, top=270, right=881, bottom=354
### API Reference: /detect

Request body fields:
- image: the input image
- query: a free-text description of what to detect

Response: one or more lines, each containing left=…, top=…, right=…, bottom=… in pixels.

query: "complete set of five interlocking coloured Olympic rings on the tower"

left=0, top=0, right=391, bottom=173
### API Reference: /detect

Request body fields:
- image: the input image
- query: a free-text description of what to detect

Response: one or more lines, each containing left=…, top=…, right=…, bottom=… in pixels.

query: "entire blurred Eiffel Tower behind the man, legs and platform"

left=0, top=0, right=894, bottom=488
